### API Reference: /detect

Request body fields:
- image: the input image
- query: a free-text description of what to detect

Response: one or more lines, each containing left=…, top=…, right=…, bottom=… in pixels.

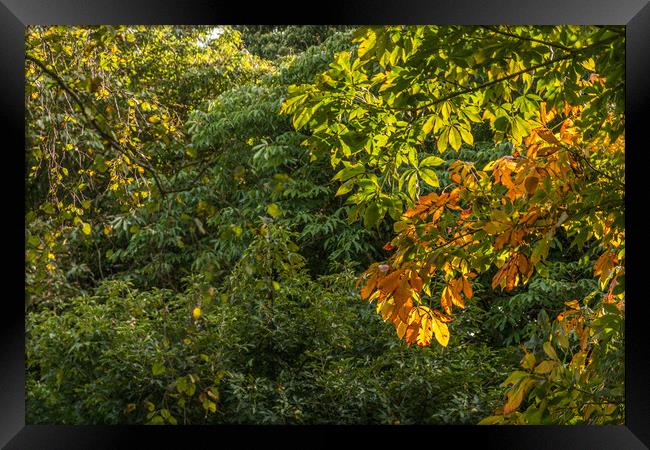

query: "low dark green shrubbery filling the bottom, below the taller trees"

left=27, top=227, right=508, bottom=424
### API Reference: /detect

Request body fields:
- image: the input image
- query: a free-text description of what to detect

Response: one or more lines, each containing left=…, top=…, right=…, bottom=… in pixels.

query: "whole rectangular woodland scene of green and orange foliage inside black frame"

left=25, top=26, right=625, bottom=425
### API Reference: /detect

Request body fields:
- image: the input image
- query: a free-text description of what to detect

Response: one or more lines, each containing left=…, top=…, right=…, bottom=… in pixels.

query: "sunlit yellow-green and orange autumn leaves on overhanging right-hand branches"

left=283, top=26, right=625, bottom=421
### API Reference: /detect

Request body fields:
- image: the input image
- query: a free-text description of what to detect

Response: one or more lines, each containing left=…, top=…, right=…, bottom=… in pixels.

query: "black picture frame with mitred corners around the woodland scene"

left=0, top=0, right=650, bottom=450
